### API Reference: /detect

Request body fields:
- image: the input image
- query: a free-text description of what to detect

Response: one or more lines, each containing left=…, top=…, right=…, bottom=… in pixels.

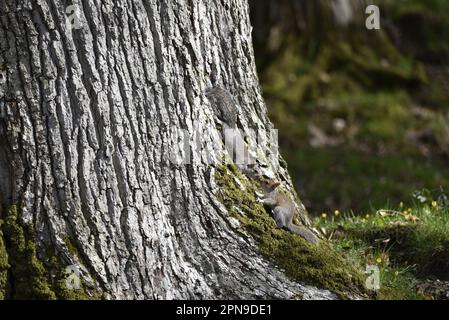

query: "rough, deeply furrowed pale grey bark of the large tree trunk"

left=0, top=0, right=334, bottom=299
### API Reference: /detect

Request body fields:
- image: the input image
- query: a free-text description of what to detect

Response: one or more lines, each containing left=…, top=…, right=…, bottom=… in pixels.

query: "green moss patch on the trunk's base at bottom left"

left=0, top=206, right=101, bottom=300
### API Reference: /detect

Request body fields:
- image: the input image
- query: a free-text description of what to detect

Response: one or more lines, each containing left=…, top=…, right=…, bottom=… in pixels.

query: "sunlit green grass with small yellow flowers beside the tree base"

left=315, top=190, right=449, bottom=299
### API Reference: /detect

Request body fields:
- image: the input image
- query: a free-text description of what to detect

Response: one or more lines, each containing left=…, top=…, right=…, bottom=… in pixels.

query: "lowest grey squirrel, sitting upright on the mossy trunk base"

left=259, top=182, right=319, bottom=244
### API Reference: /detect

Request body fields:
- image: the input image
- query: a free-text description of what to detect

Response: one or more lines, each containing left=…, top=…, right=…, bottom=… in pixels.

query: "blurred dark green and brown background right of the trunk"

left=250, top=0, right=449, bottom=214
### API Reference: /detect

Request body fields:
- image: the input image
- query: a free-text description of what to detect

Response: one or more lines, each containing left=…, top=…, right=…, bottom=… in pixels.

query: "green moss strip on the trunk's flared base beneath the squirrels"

left=215, top=165, right=367, bottom=298
